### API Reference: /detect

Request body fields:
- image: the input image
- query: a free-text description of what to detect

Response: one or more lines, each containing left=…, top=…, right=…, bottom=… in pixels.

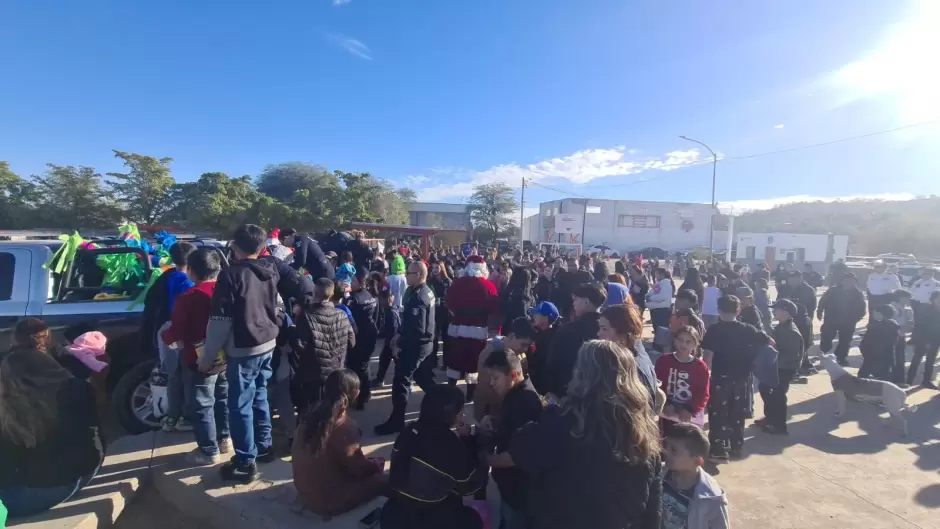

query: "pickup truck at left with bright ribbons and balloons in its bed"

left=0, top=240, right=225, bottom=434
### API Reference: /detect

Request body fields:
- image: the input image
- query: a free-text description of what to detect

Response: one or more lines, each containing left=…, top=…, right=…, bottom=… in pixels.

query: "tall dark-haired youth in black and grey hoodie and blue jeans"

left=207, top=224, right=281, bottom=482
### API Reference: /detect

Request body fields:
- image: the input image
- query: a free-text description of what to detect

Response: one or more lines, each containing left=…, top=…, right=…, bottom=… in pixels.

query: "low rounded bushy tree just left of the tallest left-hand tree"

left=30, top=163, right=122, bottom=231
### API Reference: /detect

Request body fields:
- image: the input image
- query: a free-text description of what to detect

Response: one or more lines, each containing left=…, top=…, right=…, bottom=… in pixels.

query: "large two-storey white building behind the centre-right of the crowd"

left=522, top=198, right=713, bottom=252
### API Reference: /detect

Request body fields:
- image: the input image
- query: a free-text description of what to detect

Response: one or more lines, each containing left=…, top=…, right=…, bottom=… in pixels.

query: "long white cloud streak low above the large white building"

left=418, top=146, right=701, bottom=201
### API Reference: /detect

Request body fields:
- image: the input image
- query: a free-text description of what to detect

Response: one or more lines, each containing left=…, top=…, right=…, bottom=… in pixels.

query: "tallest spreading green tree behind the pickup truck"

left=107, top=150, right=176, bottom=224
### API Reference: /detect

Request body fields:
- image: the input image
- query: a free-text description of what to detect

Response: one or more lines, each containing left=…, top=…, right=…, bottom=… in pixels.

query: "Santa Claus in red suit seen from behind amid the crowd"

left=444, top=255, right=499, bottom=401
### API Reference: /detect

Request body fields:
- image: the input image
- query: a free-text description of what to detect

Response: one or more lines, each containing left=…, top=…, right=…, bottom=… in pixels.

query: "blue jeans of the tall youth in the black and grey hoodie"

left=225, top=352, right=272, bottom=466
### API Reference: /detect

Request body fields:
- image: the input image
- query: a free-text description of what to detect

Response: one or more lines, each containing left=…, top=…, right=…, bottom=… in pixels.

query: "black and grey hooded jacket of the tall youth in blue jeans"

left=209, top=259, right=280, bottom=349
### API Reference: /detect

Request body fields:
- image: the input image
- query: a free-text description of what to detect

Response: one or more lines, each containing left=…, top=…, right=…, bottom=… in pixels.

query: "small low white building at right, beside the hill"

left=735, top=233, right=849, bottom=270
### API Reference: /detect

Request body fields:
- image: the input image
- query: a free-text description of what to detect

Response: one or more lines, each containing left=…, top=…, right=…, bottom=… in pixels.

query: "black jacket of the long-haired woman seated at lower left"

left=0, top=376, right=104, bottom=489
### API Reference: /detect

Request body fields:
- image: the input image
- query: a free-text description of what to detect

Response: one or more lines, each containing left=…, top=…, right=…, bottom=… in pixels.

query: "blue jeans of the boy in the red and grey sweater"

left=183, top=366, right=231, bottom=456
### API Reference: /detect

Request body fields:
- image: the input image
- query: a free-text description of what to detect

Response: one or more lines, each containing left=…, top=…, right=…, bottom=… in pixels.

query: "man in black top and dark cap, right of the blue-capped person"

left=545, top=283, right=607, bottom=400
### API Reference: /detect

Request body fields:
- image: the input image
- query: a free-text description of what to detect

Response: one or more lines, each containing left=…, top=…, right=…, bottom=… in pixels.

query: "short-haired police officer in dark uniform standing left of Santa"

left=375, top=261, right=436, bottom=435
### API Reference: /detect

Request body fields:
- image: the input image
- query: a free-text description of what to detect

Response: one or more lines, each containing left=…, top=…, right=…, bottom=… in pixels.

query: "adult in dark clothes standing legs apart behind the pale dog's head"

left=816, top=273, right=867, bottom=367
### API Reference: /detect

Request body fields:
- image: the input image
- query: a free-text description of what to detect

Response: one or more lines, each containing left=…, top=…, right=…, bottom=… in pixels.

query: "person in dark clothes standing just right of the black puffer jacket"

left=346, top=266, right=379, bottom=410
